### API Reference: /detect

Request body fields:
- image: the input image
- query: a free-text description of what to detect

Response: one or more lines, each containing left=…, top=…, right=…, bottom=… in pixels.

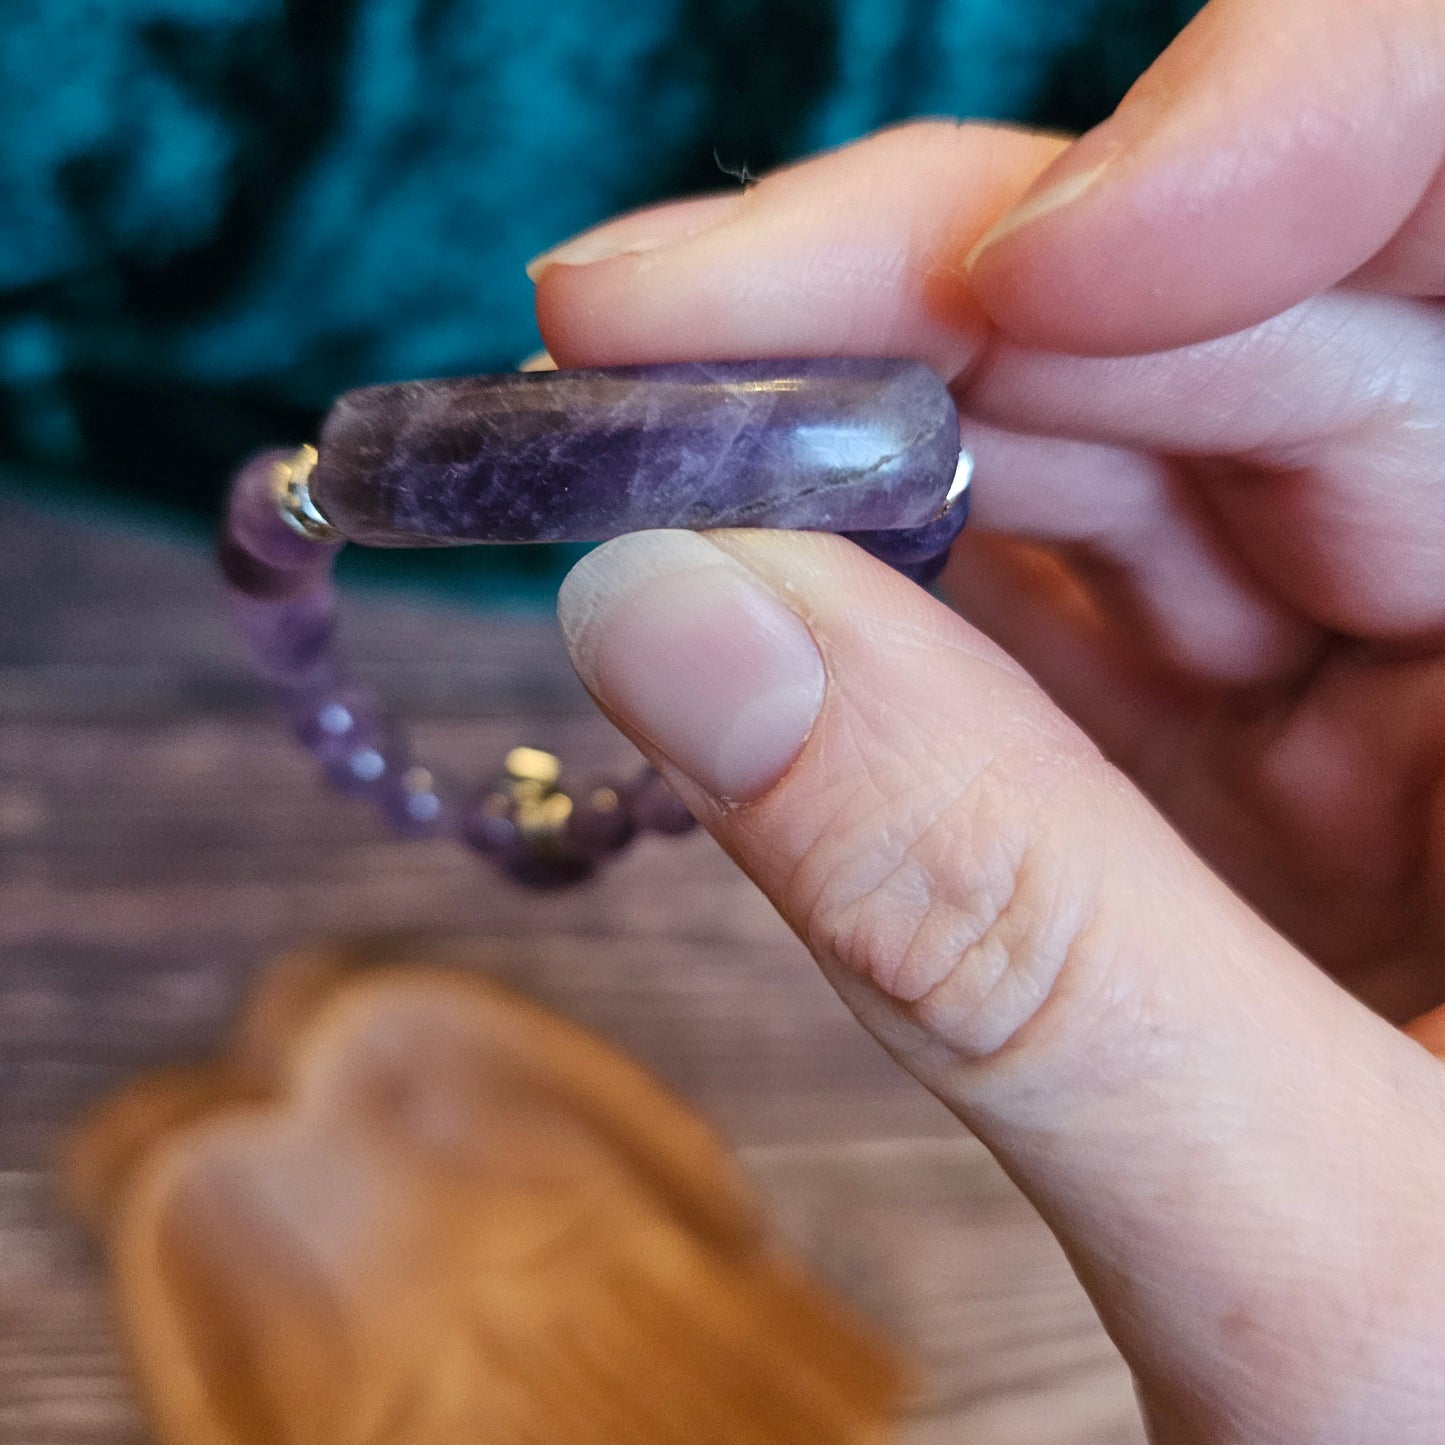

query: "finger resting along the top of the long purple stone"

left=529, top=121, right=1064, bottom=380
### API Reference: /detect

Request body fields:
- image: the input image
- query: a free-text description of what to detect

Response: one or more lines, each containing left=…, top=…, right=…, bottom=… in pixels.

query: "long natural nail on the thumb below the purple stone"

left=558, top=532, right=825, bottom=802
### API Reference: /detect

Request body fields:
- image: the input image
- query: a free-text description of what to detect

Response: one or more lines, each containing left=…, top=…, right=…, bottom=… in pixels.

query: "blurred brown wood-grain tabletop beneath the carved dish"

left=0, top=501, right=1142, bottom=1445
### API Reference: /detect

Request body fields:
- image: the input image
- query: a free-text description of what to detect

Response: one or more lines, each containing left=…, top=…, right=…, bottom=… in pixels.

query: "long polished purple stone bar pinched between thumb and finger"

left=311, top=358, right=958, bottom=546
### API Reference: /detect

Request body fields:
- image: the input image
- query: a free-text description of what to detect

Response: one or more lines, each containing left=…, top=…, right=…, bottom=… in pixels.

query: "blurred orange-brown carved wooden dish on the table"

left=65, top=954, right=902, bottom=1445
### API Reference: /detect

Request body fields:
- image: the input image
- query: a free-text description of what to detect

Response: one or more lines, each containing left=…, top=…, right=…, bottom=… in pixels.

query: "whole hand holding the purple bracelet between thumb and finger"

left=535, top=0, right=1445, bottom=1445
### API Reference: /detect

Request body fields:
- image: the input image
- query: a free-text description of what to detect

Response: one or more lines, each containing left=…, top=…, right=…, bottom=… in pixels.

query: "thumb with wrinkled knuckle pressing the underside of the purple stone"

left=561, top=532, right=1445, bottom=1442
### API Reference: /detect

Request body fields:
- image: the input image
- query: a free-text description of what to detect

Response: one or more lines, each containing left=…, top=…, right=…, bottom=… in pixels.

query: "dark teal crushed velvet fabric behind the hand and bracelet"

left=0, top=0, right=1195, bottom=598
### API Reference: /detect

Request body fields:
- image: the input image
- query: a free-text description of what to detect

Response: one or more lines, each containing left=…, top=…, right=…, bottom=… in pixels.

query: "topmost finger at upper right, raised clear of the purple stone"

left=971, top=0, right=1445, bottom=354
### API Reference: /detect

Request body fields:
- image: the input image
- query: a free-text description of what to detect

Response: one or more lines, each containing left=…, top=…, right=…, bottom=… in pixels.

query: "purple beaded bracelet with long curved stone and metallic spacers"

left=218, top=358, right=972, bottom=887
